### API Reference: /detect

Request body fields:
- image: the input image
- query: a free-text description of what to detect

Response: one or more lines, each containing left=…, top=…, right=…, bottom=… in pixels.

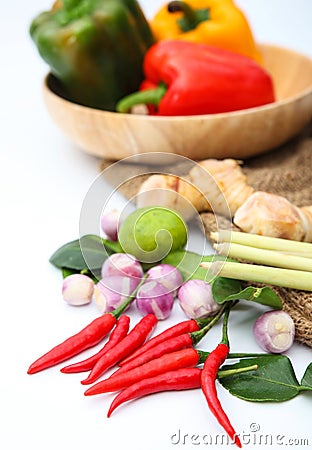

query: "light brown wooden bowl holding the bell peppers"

left=44, top=45, right=312, bottom=160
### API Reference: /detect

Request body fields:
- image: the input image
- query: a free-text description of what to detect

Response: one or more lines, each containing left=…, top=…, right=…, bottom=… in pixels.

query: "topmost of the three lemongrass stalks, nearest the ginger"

left=210, top=230, right=312, bottom=257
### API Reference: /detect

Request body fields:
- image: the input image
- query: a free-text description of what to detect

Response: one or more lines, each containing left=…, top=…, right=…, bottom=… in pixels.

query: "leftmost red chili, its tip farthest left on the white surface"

left=27, top=313, right=116, bottom=374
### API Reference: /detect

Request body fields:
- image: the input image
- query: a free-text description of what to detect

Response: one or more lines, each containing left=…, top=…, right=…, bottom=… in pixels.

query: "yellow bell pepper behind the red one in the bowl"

left=150, top=0, right=262, bottom=63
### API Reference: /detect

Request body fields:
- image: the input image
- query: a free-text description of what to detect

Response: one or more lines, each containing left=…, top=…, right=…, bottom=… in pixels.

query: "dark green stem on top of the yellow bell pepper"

left=167, top=0, right=210, bottom=32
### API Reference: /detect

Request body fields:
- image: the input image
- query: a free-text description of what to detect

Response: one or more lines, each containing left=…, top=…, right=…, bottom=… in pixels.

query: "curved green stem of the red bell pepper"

left=116, top=83, right=167, bottom=113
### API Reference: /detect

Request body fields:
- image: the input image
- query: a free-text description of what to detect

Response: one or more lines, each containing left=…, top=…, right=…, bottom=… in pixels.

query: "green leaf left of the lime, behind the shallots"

left=49, top=234, right=121, bottom=271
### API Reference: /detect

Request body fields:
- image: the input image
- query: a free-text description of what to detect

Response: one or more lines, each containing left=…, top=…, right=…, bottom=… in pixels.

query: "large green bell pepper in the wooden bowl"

left=30, top=0, right=153, bottom=111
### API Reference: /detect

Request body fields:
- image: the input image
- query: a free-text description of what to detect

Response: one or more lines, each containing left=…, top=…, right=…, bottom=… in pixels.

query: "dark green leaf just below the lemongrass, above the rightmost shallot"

left=212, top=277, right=283, bottom=309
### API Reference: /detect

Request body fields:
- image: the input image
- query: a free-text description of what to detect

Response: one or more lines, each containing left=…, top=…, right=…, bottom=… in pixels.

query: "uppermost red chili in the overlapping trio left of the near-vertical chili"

left=119, top=319, right=201, bottom=366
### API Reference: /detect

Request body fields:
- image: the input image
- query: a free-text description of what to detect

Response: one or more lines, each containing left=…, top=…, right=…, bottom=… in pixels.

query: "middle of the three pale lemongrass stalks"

left=213, top=243, right=312, bottom=272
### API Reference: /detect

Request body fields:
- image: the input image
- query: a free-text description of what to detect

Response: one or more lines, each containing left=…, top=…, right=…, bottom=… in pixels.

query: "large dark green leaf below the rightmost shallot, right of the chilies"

left=220, top=355, right=301, bottom=402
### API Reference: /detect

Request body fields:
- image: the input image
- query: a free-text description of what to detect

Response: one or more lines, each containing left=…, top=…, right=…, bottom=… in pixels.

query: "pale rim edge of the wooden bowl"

left=43, top=44, right=312, bottom=122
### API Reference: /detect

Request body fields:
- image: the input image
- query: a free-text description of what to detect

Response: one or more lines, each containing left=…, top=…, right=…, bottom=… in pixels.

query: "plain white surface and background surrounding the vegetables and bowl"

left=0, top=0, right=312, bottom=450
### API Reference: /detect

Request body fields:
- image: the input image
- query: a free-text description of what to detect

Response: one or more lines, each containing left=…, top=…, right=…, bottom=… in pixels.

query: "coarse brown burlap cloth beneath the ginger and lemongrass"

left=101, top=125, right=312, bottom=347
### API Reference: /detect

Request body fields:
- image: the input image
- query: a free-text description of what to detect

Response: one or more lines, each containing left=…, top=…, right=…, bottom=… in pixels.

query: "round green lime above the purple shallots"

left=118, top=206, right=187, bottom=263
